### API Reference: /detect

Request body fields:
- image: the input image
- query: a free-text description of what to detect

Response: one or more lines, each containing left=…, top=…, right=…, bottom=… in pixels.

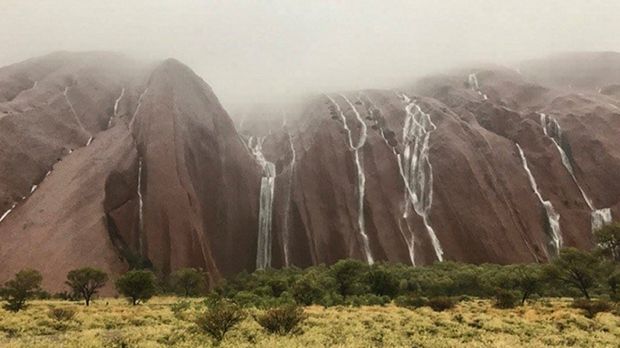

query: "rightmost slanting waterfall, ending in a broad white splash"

left=540, top=113, right=612, bottom=231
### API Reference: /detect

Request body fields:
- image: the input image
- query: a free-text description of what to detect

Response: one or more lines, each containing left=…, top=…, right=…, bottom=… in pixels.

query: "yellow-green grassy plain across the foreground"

left=0, top=297, right=620, bottom=348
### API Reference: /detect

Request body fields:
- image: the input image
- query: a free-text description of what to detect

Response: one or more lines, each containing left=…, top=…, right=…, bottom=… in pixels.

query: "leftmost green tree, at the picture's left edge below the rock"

left=2, top=269, right=43, bottom=312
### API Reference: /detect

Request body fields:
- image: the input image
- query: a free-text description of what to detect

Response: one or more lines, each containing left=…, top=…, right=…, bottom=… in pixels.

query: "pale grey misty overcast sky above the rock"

left=0, top=0, right=620, bottom=103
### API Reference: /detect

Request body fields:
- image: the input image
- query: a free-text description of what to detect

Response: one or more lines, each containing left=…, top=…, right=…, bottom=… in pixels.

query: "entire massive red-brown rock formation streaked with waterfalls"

left=0, top=53, right=620, bottom=291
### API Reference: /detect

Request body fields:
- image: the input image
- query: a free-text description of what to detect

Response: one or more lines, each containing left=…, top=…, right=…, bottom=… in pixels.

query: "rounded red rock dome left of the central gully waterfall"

left=0, top=53, right=260, bottom=291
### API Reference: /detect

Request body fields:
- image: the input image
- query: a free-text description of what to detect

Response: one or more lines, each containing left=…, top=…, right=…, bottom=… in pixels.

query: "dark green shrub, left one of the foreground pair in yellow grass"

left=196, top=300, right=246, bottom=344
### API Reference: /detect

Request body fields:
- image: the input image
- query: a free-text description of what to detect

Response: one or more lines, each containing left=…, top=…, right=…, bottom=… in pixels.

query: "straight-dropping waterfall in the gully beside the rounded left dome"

left=248, top=137, right=276, bottom=269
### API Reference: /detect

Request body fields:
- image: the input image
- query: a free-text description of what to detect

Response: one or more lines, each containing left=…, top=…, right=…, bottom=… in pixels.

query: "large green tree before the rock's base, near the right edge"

left=548, top=248, right=601, bottom=299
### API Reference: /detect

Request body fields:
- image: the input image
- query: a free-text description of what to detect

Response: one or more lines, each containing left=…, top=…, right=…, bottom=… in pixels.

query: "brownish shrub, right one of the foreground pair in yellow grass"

left=254, top=305, right=307, bottom=335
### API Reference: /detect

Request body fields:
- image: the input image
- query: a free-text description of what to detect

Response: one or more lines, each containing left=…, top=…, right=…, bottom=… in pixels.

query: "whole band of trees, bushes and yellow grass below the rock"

left=0, top=224, right=620, bottom=347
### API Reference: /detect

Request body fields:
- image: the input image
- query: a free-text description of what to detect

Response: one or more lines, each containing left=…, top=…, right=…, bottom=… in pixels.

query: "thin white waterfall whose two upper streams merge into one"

left=326, top=94, right=374, bottom=264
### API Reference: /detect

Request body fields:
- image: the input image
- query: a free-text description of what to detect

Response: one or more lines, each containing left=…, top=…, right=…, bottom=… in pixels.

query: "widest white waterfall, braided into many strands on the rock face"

left=397, top=94, right=443, bottom=261
